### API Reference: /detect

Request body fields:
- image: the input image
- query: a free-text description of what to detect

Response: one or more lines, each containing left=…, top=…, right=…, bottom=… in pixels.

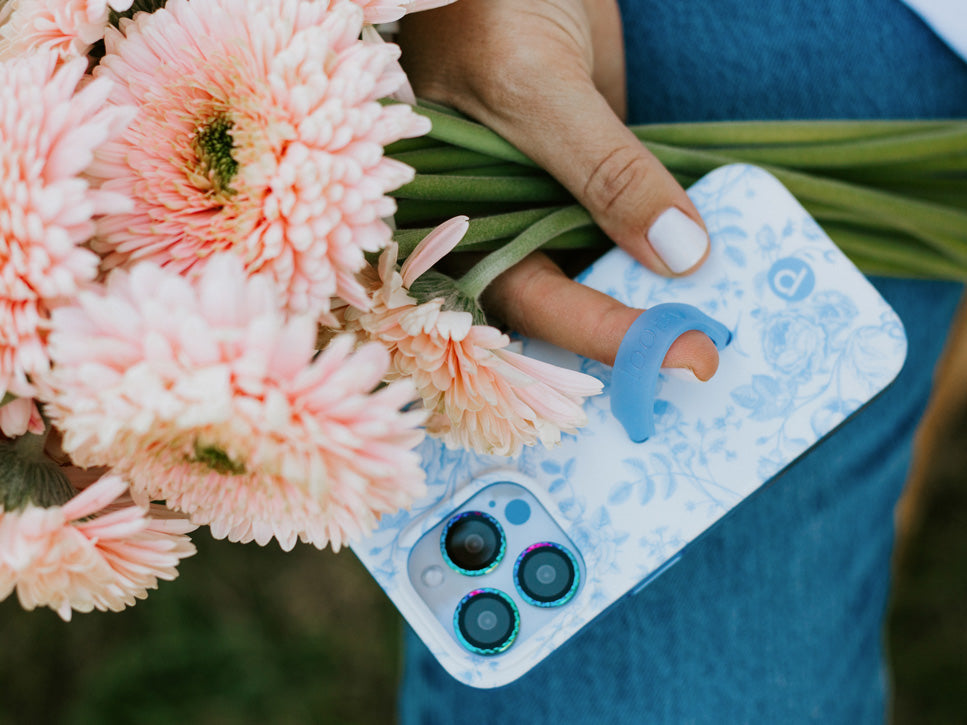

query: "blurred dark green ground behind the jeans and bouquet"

left=0, top=335, right=967, bottom=725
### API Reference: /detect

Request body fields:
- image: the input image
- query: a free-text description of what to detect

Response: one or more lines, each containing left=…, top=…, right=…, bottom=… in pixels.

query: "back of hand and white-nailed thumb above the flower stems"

left=400, top=0, right=709, bottom=275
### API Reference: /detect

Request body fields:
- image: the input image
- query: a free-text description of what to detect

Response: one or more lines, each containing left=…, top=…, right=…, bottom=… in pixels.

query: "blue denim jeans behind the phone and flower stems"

left=400, top=0, right=967, bottom=725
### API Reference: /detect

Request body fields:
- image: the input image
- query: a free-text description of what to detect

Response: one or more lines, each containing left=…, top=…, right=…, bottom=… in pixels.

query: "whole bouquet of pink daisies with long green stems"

left=0, top=0, right=967, bottom=620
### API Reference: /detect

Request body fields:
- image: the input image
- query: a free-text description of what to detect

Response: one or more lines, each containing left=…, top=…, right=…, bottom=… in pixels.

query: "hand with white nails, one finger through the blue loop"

left=399, top=0, right=718, bottom=380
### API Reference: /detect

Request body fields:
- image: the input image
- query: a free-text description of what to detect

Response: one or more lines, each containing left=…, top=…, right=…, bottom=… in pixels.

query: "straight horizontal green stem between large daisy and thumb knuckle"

left=392, top=174, right=572, bottom=203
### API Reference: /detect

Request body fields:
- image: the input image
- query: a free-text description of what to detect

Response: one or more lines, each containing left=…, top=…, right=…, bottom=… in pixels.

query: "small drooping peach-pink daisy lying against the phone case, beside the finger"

left=347, top=218, right=602, bottom=456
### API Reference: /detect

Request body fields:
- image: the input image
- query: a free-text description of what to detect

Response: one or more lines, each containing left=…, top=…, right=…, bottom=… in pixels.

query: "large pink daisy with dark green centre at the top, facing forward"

left=92, top=0, right=429, bottom=314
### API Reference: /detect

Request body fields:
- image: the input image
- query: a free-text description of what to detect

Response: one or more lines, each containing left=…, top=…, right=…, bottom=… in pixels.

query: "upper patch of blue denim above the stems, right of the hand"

left=620, top=0, right=967, bottom=123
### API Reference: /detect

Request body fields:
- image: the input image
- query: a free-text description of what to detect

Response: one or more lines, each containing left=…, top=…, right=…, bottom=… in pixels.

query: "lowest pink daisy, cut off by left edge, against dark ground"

left=0, top=476, right=195, bottom=621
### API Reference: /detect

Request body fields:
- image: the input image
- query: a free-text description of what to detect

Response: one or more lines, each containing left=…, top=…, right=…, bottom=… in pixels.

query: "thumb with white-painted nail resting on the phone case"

left=483, top=75, right=709, bottom=276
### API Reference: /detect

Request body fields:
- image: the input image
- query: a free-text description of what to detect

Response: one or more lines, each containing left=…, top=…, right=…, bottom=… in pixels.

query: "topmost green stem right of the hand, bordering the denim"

left=631, top=121, right=963, bottom=148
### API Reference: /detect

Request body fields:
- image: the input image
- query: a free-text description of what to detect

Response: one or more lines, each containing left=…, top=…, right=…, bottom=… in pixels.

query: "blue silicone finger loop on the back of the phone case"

left=611, top=302, right=732, bottom=443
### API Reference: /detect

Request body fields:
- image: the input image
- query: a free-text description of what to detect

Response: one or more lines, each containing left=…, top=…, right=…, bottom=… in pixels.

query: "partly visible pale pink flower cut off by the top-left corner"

left=0, top=0, right=133, bottom=58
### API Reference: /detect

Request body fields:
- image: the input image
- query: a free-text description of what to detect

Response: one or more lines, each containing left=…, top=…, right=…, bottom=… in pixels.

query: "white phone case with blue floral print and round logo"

left=353, top=165, right=906, bottom=687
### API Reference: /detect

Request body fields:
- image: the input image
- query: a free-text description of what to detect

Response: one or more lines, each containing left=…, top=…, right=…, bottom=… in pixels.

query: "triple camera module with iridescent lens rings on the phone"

left=409, top=482, right=583, bottom=655
